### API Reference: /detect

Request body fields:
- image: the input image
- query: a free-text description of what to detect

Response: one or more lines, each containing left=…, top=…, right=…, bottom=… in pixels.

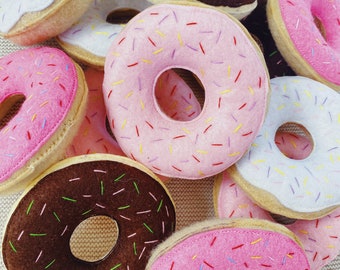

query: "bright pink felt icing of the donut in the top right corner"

left=278, top=0, right=340, bottom=85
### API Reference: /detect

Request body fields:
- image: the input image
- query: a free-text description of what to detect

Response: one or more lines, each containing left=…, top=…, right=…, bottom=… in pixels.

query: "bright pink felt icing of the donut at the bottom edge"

left=150, top=223, right=309, bottom=270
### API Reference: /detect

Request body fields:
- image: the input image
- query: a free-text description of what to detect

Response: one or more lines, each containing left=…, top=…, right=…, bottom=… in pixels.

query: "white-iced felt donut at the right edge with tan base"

left=230, top=76, right=340, bottom=219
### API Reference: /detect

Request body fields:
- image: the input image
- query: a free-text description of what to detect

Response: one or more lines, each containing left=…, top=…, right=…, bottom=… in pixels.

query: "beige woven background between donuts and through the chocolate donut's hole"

left=0, top=35, right=340, bottom=270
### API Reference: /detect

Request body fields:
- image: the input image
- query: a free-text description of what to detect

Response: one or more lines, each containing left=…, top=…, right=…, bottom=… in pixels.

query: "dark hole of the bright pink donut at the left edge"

left=0, top=94, right=26, bottom=130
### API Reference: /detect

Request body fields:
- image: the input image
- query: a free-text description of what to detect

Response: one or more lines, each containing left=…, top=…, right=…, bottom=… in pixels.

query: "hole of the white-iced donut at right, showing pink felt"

left=275, top=122, right=314, bottom=160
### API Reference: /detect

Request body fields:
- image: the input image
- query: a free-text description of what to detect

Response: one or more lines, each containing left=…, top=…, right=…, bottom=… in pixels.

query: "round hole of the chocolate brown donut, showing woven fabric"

left=70, top=216, right=119, bottom=263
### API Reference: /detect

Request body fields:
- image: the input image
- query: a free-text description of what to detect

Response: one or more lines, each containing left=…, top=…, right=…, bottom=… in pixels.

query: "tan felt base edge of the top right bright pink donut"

left=267, top=0, right=340, bottom=91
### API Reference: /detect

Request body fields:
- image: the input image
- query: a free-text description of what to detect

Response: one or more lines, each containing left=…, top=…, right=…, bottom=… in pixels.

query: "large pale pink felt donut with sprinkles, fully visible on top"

left=103, top=4, right=269, bottom=179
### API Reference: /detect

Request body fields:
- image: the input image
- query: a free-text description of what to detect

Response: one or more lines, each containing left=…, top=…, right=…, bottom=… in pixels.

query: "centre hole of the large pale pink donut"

left=155, top=68, right=205, bottom=122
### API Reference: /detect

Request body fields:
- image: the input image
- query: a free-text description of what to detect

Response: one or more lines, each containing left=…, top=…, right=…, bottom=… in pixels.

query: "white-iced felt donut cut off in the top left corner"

left=0, top=0, right=92, bottom=45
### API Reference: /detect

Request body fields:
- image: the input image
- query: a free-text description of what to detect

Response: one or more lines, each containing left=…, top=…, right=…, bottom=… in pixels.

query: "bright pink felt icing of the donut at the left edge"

left=0, top=47, right=78, bottom=182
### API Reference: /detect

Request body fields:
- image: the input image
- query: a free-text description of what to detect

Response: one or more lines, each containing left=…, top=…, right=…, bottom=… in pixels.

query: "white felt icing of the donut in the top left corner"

left=0, top=0, right=54, bottom=33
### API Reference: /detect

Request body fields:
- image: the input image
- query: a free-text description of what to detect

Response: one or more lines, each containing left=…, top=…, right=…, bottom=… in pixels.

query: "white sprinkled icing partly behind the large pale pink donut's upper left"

left=59, top=0, right=151, bottom=57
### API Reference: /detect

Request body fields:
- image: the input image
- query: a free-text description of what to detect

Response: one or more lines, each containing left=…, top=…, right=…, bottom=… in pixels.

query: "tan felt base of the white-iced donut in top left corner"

left=3, top=0, right=92, bottom=45
